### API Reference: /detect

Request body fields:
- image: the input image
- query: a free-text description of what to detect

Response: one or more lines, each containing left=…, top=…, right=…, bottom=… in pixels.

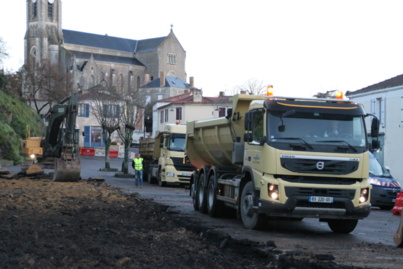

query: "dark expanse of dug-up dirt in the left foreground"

left=0, top=178, right=360, bottom=268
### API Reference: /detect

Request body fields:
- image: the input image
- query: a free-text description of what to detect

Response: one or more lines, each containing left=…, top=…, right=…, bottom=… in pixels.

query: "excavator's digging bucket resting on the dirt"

left=53, top=158, right=81, bottom=182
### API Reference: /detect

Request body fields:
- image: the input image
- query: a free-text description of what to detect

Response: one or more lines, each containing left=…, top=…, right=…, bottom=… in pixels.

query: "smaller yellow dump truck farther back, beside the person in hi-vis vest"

left=139, top=124, right=194, bottom=186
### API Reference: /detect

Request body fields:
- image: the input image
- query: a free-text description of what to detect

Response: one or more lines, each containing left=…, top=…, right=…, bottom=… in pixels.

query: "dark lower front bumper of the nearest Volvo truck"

left=256, top=196, right=371, bottom=219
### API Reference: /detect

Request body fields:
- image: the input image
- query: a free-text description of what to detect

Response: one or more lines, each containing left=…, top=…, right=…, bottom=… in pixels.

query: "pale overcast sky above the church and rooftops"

left=0, top=0, right=403, bottom=97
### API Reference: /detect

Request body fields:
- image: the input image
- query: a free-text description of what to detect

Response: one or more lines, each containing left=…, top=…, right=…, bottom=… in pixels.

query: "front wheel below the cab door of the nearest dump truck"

left=239, top=181, right=266, bottom=230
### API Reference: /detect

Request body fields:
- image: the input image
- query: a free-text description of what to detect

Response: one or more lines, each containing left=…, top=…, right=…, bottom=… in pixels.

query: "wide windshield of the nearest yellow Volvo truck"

left=267, top=111, right=367, bottom=153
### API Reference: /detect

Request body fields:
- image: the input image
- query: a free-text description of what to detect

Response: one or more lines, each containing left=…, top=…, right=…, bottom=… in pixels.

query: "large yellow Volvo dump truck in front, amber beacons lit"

left=186, top=95, right=379, bottom=233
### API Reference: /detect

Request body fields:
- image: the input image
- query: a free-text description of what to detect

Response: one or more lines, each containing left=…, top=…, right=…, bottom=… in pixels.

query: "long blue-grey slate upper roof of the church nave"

left=62, top=29, right=166, bottom=53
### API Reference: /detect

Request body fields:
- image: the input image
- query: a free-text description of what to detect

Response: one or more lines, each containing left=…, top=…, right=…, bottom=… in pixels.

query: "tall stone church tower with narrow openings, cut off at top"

left=25, top=0, right=63, bottom=67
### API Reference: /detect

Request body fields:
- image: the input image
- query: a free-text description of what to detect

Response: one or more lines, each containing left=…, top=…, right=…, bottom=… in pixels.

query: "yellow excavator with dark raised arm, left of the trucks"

left=21, top=93, right=81, bottom=182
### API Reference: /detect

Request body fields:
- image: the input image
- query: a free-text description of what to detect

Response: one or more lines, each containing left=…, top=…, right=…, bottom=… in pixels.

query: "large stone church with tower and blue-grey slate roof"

left=24, top=0, right=191, bottom=102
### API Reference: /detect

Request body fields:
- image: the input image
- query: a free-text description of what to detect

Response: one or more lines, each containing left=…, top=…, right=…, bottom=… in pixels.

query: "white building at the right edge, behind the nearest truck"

left=346, top=75, right=403, bottom=185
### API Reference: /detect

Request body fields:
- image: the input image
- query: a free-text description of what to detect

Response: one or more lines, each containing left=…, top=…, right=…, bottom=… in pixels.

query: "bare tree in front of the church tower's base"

left=23, top=62, right=73, bottom=116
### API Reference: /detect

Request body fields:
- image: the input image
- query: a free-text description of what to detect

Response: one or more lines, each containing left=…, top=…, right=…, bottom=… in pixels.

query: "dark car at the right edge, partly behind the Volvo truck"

left=368, top=153, right=401, bottom=210
